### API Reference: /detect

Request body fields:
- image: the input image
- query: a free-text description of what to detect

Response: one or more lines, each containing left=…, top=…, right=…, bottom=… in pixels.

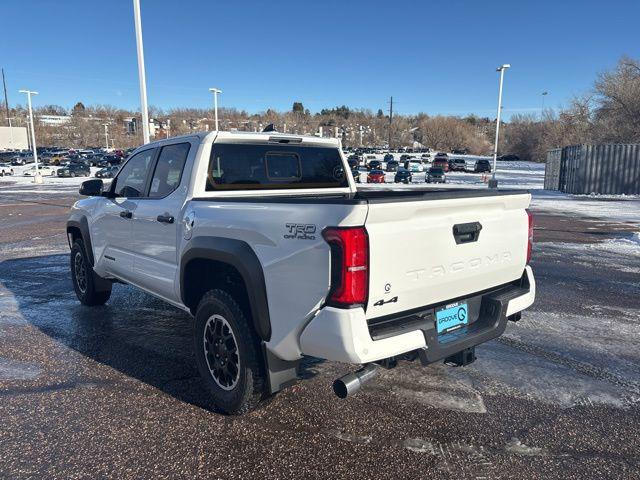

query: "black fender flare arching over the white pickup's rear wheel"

left=180, top=236, right=271, bottom=341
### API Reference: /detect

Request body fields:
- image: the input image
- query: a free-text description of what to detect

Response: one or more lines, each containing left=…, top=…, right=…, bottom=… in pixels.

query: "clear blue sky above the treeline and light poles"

left=0, top=0, right=640, bottom=117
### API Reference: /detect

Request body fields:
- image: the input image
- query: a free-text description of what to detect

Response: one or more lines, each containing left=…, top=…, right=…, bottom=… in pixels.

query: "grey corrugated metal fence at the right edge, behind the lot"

left=544, top=144, right=640, bottom=195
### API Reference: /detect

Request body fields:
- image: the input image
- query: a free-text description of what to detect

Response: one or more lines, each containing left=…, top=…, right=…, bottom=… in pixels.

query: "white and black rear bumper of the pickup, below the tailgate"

left=300, top=266, right=536, bottom=364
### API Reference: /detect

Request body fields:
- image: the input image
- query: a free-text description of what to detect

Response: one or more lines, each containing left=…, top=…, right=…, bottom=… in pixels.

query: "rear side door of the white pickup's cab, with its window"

left=132, top=141, right=191, bottom=301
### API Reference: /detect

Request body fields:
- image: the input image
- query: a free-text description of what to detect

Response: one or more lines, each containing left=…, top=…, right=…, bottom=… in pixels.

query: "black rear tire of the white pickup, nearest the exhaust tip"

left=194, top=289, right=267, bottom=415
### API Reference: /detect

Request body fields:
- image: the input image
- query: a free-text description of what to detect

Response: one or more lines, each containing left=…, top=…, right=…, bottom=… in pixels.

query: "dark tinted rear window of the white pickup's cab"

left=206, top=143, right=349, bottom=192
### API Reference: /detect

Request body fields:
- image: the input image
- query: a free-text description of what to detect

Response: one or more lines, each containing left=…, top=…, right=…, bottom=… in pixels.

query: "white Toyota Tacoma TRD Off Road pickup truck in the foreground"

left=67, top=132, right=535, bottom=414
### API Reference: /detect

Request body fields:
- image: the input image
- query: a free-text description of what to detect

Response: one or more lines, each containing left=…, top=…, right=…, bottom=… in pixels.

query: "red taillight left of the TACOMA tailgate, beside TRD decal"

left=322, top=227, right=369, bottom=307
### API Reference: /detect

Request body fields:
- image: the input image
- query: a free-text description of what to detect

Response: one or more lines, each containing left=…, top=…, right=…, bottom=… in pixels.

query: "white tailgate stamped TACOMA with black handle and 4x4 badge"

left=365, top=192, right=531, bottom=319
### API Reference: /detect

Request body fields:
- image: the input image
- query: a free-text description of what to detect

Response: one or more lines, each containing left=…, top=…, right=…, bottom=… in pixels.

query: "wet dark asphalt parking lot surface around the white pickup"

left=0, top=188, right=640, bottom=479
